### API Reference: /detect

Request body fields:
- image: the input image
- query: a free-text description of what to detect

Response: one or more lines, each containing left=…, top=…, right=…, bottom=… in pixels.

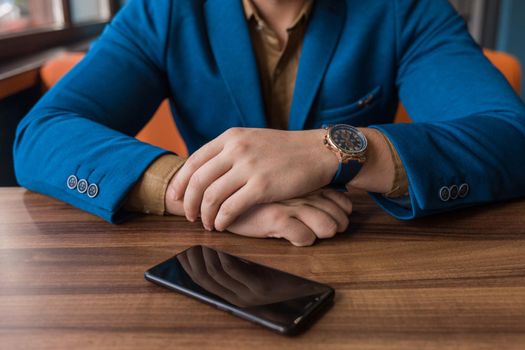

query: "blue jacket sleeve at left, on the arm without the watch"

left=14, top=0, right=171, bottom=222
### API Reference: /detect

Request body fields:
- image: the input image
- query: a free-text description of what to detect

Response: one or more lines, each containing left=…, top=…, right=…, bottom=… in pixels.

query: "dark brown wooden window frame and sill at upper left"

left=0, top=0, right=121, bottom=63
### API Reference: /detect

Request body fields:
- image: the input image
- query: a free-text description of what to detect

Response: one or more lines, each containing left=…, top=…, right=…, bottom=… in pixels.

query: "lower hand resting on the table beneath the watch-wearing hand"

left=227, top=189, right=352, bottom=246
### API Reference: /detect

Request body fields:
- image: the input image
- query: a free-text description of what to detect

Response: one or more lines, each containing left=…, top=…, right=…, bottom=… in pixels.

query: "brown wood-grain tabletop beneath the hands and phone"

left=0, top=188, right=525, bottom=349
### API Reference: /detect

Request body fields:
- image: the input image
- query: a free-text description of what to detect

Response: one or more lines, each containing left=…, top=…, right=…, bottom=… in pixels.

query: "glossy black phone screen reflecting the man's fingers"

left=150, top=246, right=331, bottom=324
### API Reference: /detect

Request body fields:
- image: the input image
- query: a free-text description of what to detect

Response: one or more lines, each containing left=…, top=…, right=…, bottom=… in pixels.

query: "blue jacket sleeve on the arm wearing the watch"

left=372, top=0, right=525, bottom=219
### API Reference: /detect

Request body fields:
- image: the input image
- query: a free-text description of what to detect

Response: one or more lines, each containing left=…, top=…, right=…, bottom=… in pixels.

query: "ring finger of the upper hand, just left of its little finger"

left=200, top=170, right=246, bottom=230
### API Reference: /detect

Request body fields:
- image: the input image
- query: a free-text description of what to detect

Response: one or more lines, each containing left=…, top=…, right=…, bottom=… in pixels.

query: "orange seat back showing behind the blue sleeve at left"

left=40, top=53, right=188, bottom=157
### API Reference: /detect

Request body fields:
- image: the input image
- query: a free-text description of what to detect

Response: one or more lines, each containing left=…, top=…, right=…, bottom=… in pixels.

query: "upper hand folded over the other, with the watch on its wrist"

left=167, top=128, right=339, bottom=231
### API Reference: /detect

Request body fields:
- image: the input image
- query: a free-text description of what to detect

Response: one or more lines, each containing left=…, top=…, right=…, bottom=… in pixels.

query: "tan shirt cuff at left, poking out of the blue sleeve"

left=124, top=154, right=185, bottom=215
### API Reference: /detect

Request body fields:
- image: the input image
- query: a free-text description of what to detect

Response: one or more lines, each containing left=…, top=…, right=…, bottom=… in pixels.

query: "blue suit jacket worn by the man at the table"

left=14, top=0, right=525, bottom=221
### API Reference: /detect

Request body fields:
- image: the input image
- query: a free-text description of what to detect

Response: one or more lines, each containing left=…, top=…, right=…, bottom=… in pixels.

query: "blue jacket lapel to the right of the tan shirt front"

left=288, top=0, right=346, bottom=130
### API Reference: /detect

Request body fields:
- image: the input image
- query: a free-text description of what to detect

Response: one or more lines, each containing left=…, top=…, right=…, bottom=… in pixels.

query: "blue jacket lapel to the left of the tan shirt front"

left=205, top=0, right=267, bottom=128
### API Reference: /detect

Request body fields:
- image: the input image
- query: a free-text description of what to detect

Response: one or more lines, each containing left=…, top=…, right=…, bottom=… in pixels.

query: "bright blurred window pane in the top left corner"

left=0, top=0, right=64, bottom=36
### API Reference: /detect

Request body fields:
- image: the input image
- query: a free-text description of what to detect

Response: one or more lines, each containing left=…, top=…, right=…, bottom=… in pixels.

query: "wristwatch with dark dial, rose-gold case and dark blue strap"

left=324, top=124, right=368, bottom=189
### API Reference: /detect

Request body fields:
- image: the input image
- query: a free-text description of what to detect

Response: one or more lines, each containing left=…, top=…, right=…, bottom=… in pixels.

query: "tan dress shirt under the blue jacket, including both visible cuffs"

left=125, top=0, right=408, bottom=215
